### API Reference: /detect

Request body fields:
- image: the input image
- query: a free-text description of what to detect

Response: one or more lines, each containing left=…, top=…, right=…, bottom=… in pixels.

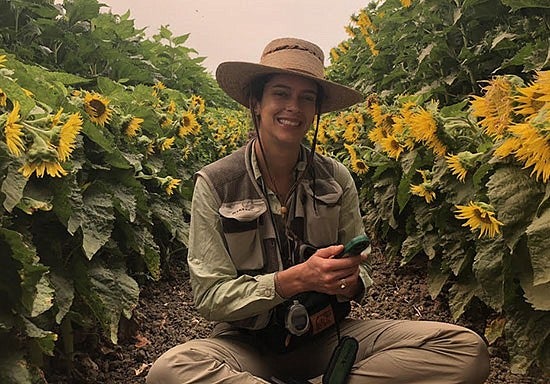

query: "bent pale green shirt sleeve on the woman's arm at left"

left=187, top=176, right=284, bottom=321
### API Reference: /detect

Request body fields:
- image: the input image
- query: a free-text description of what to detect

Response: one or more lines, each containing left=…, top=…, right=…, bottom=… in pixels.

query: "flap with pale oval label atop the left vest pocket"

left=218, top=199, right=267, bottom=233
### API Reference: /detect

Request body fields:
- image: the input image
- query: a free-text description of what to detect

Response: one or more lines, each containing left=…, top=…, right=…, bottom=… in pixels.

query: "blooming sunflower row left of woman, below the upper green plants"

left=0, top=51, right=249, bottom=383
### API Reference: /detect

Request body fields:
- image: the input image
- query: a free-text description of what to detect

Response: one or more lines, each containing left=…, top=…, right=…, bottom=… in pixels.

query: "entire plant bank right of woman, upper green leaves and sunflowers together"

left=325, top=0, right=550, bottom=373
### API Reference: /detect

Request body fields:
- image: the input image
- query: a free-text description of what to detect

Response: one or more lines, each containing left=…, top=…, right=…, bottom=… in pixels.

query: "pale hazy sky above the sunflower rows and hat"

left=101, top=0, right=369, bottom=73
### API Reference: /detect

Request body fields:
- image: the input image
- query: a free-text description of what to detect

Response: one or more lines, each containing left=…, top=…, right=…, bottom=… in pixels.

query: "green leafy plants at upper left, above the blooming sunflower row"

left=0, top=0, right=235, bottom=107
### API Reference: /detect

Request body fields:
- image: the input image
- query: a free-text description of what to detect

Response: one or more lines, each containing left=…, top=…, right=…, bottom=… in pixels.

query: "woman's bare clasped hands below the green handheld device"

left=276, top=245, right=361, bottom=298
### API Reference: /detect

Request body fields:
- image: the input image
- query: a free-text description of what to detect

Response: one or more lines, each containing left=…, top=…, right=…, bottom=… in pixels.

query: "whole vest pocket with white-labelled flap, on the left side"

left=219, top=200, right=267, bottom=271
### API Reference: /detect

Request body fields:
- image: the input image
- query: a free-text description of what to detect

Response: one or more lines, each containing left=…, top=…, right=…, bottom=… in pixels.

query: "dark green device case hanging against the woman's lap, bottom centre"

left=323, top=336, right=359, bottom=384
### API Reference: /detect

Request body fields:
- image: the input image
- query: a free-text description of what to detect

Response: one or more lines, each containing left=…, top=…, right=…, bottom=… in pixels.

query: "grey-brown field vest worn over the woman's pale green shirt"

left=197, top=140, right=343, bottom=275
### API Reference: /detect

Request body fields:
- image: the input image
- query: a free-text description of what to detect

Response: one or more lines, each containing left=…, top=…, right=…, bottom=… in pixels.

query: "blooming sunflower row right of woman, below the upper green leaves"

left=312, top=72, right=550, bottom=373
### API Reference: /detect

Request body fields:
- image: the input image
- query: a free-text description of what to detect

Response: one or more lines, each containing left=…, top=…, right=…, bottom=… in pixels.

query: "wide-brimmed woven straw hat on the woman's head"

left=216, top=38, right=363, bottom=113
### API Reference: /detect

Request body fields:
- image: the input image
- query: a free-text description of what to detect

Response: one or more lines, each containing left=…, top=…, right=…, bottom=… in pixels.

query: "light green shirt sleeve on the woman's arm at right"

left=334, top=162, right=373, bottom=303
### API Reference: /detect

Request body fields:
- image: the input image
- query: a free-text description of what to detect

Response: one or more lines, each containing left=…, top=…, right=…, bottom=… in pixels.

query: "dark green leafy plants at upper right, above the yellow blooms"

left=329, top=0, right=550, bottom=105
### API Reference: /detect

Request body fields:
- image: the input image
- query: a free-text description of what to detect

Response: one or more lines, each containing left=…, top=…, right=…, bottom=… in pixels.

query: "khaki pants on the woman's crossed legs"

left=147, top=319, right=489, bottom=384
